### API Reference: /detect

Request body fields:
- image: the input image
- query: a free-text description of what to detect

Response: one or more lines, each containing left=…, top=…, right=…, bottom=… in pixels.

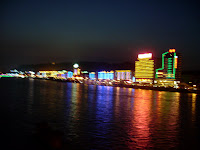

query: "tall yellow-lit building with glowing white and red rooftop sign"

left=135, top=53, right=154, bottom=83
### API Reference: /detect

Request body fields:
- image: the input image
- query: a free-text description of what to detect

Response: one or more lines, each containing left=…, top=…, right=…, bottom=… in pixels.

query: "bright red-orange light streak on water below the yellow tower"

left=129, top=89, right=152, bottom=148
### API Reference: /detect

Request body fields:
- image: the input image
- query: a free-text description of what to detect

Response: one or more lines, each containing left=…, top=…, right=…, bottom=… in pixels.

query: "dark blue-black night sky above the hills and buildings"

left=0, top=0, right=200, bottom=70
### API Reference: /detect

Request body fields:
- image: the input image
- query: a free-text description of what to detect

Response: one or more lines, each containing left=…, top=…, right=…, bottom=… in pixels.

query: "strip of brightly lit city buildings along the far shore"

left=0, top=49, right=200, bottom=93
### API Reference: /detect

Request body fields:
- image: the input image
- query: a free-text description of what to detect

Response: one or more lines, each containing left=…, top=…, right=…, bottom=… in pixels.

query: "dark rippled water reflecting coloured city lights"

left=0, top=79, right=200, bottom=150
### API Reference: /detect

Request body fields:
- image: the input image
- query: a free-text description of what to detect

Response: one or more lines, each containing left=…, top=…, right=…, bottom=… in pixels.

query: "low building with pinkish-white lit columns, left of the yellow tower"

left=115, top=70, right=132, bottom=80
